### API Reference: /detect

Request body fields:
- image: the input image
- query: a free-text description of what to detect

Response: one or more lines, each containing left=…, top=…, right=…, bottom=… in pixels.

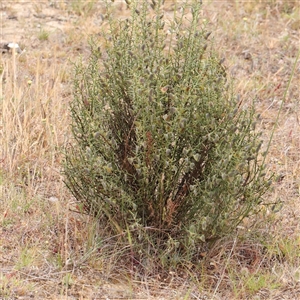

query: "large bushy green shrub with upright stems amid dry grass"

left=65, top=1, right=271, bottom=270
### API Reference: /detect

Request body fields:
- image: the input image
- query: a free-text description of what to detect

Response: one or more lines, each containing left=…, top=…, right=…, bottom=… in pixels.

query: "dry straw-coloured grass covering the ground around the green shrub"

left=0, top=0, right=300, bottom=299
